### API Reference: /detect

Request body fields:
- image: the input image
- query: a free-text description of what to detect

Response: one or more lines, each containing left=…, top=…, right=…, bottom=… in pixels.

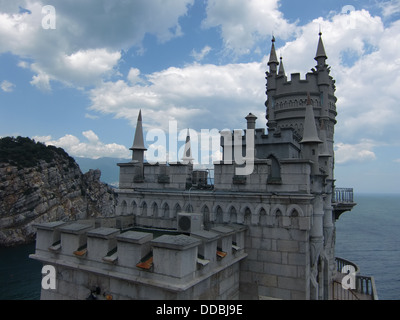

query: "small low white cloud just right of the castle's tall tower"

left=335, top=140, right=376, bottom=164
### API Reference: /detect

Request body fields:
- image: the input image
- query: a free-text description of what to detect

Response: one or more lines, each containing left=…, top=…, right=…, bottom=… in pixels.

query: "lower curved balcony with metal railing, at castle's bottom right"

left=332, top=258, right=378, bottom=300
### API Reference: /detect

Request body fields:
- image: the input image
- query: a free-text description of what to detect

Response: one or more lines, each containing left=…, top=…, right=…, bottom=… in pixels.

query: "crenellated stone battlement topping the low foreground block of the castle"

left=31, top=222, right=247, bottom=299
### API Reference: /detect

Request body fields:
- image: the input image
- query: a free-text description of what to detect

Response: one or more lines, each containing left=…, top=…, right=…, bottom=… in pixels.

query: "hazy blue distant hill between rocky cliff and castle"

left=75, top=157, right=129, bottom=186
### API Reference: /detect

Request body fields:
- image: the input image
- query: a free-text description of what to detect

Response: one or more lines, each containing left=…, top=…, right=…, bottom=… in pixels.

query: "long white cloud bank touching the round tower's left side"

left=90, top=63, right=265, bottom=129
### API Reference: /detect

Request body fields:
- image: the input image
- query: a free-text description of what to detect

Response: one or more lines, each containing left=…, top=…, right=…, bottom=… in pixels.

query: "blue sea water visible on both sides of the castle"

left=0, top=194, right=400, bottom=300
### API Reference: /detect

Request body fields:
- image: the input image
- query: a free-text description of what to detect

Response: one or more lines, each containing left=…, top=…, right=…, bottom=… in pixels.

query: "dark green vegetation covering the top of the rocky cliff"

left=0, top=137, right=75, bottom=169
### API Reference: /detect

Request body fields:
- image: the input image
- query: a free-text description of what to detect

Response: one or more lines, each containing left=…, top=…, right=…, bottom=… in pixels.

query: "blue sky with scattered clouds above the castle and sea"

left=0, top=0, right=400, bottom=193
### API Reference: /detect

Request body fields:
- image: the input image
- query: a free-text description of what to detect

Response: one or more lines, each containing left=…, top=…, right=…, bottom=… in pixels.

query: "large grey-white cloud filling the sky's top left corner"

left=0, top=0, right=193, bottom=91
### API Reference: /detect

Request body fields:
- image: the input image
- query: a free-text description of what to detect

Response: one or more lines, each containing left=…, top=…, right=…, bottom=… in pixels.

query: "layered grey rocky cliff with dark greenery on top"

left=0, top=137, right=116, bottom=246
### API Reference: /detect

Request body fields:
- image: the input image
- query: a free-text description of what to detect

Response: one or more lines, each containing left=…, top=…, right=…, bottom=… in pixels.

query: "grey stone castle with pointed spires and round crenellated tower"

left=32, top=34, right=362, bottom=300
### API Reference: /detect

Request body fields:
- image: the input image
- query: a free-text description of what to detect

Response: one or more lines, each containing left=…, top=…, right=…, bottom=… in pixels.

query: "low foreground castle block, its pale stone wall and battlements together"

left=31, top=222, right=247, bottom=299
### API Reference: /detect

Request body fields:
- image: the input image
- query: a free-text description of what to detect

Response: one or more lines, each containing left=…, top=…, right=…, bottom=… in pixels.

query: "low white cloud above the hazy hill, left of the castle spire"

left=33, top=130, right=130, bottom=159
